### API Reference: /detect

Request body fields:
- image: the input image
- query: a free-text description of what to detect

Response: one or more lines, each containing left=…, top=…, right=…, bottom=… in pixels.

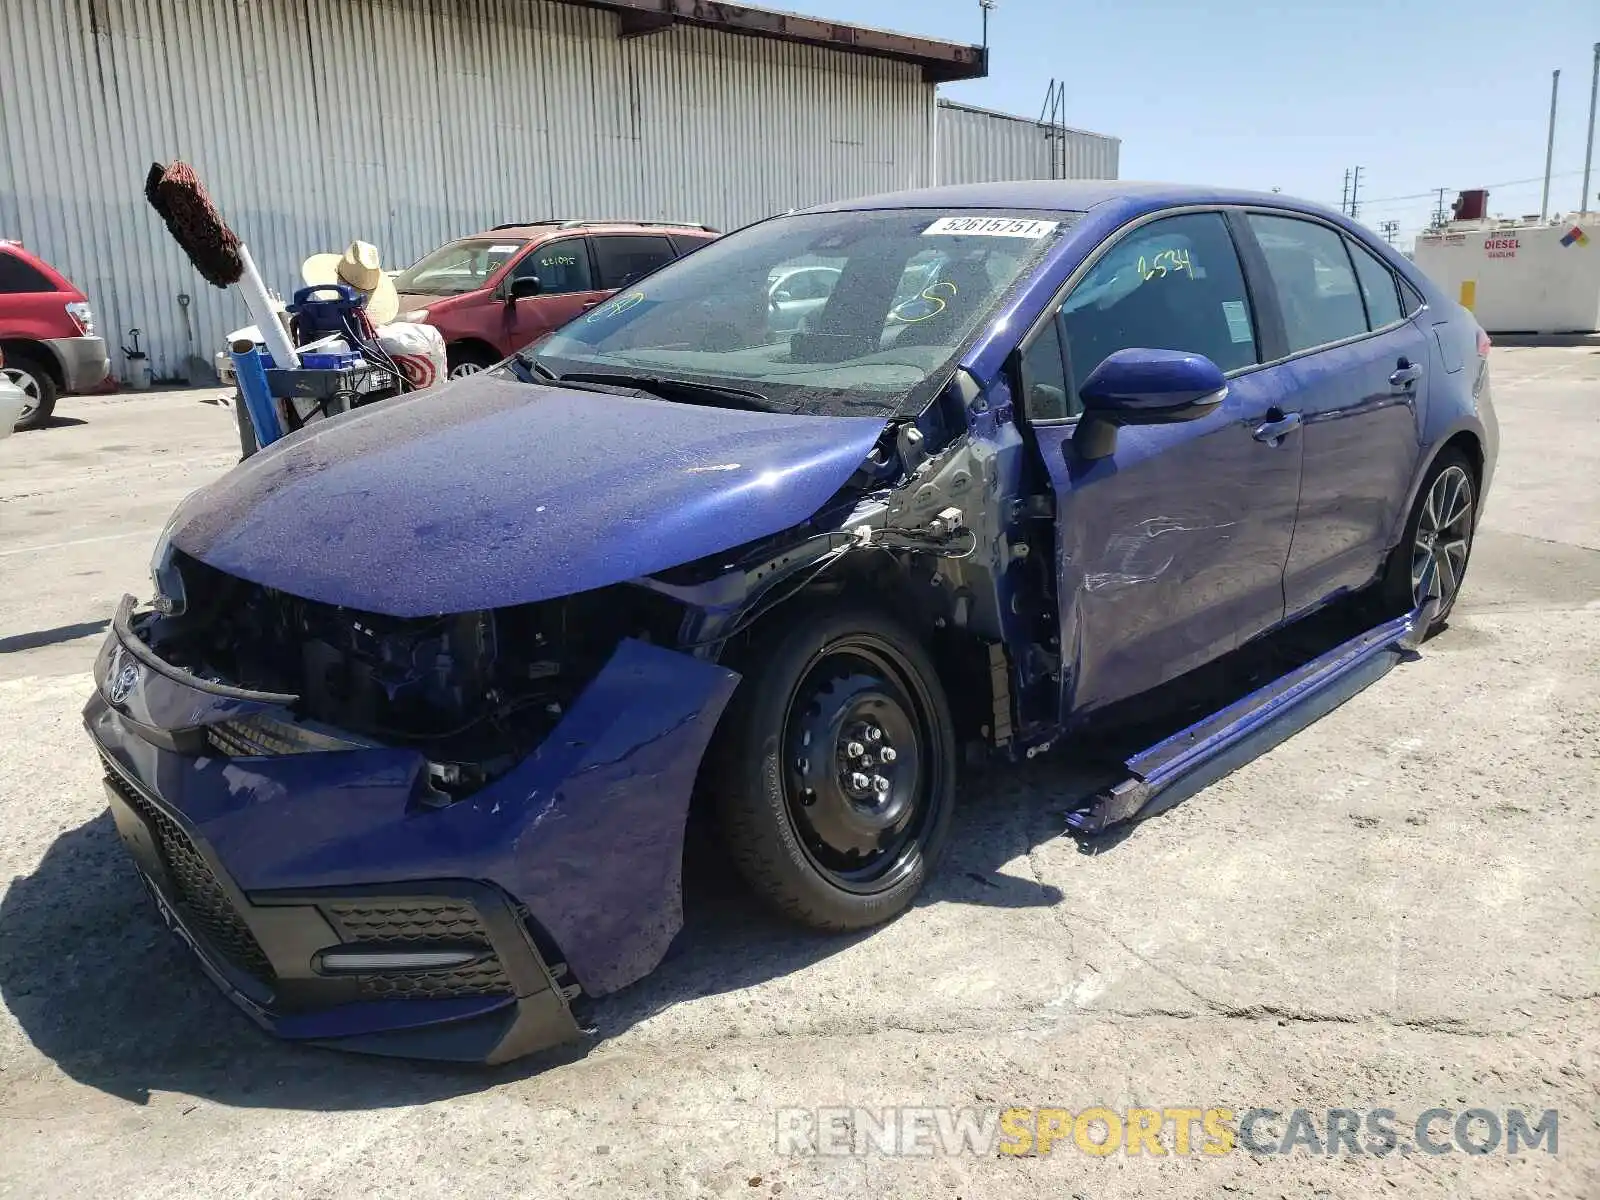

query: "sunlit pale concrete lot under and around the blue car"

left=0, top=347, right=1600, bottom=1200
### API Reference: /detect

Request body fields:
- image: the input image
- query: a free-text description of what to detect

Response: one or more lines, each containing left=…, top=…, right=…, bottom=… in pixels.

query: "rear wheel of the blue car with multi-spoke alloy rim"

left=1382, top=450, right=1478, bottom=637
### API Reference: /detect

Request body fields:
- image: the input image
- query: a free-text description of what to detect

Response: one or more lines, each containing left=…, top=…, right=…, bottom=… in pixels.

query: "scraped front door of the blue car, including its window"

left=1021, top=213, right=1301, bottom=714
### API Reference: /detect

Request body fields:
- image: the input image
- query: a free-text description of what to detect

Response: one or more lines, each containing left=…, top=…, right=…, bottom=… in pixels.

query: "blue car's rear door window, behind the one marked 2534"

left=1250, top=213, right=1366, bottom=354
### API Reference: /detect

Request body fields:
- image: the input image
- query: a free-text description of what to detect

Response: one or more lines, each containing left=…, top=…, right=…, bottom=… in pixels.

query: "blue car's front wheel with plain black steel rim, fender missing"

left=709, top=606, right=955, bottom=931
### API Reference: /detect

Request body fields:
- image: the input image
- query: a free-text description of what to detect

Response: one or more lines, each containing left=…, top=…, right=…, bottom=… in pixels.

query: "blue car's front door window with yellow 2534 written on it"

left=1061, top=213, right=1260, bottom=392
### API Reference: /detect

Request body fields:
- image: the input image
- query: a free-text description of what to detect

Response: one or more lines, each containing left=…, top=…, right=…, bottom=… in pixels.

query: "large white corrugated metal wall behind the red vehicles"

left=0, top=0, right=933, bottom=374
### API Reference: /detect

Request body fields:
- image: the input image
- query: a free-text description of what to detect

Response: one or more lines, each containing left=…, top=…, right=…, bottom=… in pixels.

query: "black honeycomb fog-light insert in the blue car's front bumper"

left=323, top=899, right=512, bottom=1000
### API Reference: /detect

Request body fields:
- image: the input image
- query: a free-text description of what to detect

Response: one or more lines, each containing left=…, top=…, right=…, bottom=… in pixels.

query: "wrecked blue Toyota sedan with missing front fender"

left=85, top=182, right=1496, bottom=1061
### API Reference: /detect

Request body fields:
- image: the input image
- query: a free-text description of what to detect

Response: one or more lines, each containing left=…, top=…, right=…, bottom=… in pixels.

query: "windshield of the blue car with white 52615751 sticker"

left=533, top=208, right=1078, bottom=416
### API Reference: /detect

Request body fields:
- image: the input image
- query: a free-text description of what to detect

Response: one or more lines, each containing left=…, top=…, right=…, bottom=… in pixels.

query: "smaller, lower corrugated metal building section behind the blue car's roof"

left=939, top=101, right=1122, bottom=184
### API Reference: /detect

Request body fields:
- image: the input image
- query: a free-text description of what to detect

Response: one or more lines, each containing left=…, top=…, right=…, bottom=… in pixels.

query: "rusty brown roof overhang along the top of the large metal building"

left=562, top=0, right=989, bottom=83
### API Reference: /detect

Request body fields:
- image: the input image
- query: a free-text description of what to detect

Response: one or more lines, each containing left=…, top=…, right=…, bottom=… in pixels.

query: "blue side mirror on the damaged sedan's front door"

left=1072, top=347, right=1227, bottom=459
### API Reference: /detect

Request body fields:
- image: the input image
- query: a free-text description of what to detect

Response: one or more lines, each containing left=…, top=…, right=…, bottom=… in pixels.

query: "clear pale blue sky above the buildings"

left=781, top=0, right=1600, bottom=246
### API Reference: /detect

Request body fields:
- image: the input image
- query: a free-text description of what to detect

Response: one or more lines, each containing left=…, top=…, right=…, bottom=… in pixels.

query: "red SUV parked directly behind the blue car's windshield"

left=395, top=221, right=717, bottom=378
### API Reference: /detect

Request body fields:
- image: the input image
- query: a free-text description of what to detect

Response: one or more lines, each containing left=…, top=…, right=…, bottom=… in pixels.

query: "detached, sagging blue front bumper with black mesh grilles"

left=83, top=602, right=738, bottom=1062
